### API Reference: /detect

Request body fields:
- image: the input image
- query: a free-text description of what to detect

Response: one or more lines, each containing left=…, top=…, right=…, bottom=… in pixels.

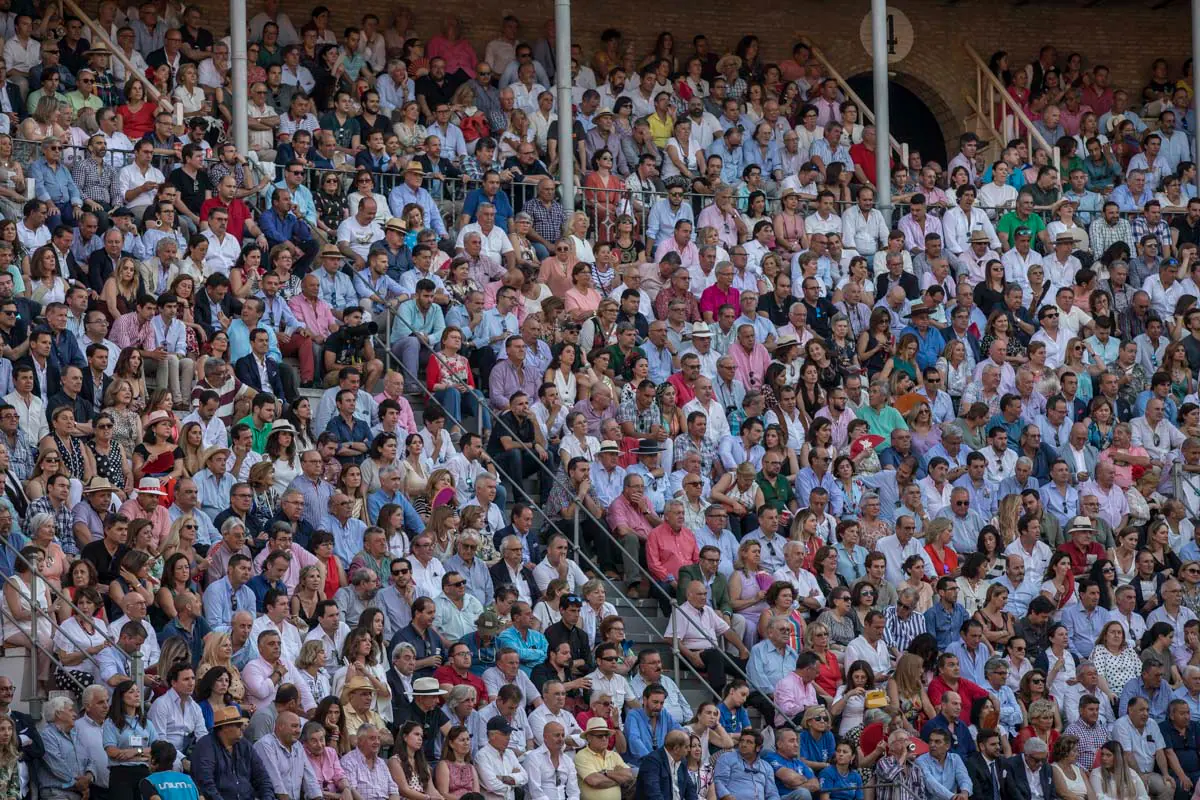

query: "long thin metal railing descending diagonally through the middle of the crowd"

left=377, top=314, right=806, bottom=723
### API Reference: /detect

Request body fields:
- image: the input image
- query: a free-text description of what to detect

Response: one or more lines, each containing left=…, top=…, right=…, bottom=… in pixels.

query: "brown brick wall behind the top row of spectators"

left=194, top=0, right=1190, bottom=151
